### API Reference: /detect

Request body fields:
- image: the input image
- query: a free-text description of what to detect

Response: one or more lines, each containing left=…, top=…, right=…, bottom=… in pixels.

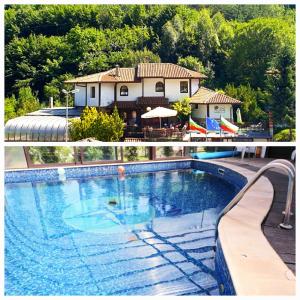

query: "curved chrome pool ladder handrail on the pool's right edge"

left=216, top=159, right=296, bottom=237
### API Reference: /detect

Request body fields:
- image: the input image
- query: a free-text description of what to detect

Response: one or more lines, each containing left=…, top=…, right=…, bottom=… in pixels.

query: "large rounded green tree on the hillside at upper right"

left=226, top=18, right=295, bottom=89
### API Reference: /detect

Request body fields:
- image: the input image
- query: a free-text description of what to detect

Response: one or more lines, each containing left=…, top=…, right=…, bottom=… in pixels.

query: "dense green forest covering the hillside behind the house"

left=5, top=5, right=295, bottom=127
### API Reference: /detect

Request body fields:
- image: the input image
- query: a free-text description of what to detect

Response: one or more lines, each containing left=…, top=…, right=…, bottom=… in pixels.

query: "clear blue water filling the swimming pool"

left=5, top=169, right=237, bottom=295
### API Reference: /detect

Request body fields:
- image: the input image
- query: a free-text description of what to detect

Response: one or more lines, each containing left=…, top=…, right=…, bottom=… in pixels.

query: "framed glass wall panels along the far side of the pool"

left=5, top=146, right=206, bottom=169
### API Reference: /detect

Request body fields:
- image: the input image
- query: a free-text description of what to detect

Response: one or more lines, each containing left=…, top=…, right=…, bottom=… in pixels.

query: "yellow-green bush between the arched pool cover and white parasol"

left=70, top=107, right=124, bottom=142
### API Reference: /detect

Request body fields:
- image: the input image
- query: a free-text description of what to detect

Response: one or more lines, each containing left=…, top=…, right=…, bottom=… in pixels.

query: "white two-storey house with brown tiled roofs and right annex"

left=65, top=63, right=240, bottom=124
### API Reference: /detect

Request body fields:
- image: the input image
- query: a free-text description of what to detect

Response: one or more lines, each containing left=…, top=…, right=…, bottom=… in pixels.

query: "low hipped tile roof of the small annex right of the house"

left=190, top=87, right=242, bottom=104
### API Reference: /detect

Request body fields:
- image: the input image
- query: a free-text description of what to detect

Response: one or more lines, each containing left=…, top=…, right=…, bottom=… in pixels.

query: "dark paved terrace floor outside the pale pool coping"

left=216, top=157, right=296, bottom=274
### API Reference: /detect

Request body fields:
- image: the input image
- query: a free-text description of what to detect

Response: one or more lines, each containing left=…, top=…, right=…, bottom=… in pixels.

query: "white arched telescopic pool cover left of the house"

left=5, top=116, right=66, bottom=142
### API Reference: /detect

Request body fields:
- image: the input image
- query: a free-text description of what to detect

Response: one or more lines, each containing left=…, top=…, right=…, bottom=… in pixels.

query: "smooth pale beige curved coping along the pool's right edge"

left=210, top=160, right=296, bottom=296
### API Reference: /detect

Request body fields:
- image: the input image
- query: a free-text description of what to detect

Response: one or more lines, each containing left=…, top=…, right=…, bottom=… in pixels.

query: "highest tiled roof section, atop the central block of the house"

left=137, top=63, right=206, bottom=78
